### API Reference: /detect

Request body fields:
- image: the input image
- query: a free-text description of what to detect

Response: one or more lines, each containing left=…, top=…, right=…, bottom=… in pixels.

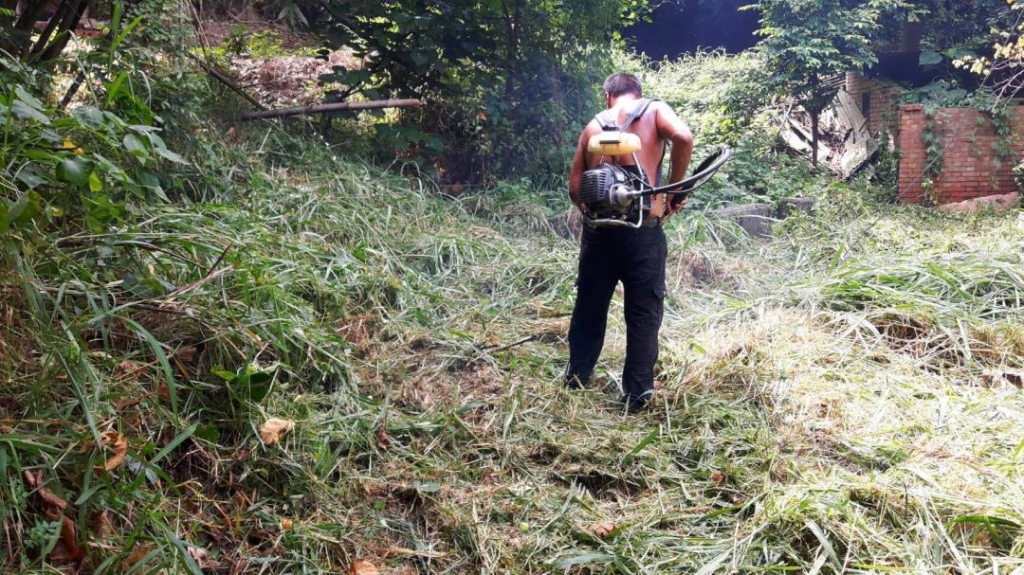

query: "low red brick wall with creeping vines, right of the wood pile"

left=897, top=104, right=1024, bottom=204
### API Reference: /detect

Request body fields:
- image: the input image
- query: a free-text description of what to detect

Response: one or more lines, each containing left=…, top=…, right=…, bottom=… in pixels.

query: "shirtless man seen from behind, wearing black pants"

left=565, top=73, right=693, bottom=413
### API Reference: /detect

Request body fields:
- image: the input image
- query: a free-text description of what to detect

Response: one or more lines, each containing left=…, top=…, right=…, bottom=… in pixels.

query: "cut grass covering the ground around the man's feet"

left=0, top=144, right=1024, bottom=574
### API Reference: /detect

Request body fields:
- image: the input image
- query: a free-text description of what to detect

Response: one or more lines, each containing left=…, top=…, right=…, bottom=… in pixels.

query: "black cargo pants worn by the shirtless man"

left=565, top=222, right=668, bottom=404
